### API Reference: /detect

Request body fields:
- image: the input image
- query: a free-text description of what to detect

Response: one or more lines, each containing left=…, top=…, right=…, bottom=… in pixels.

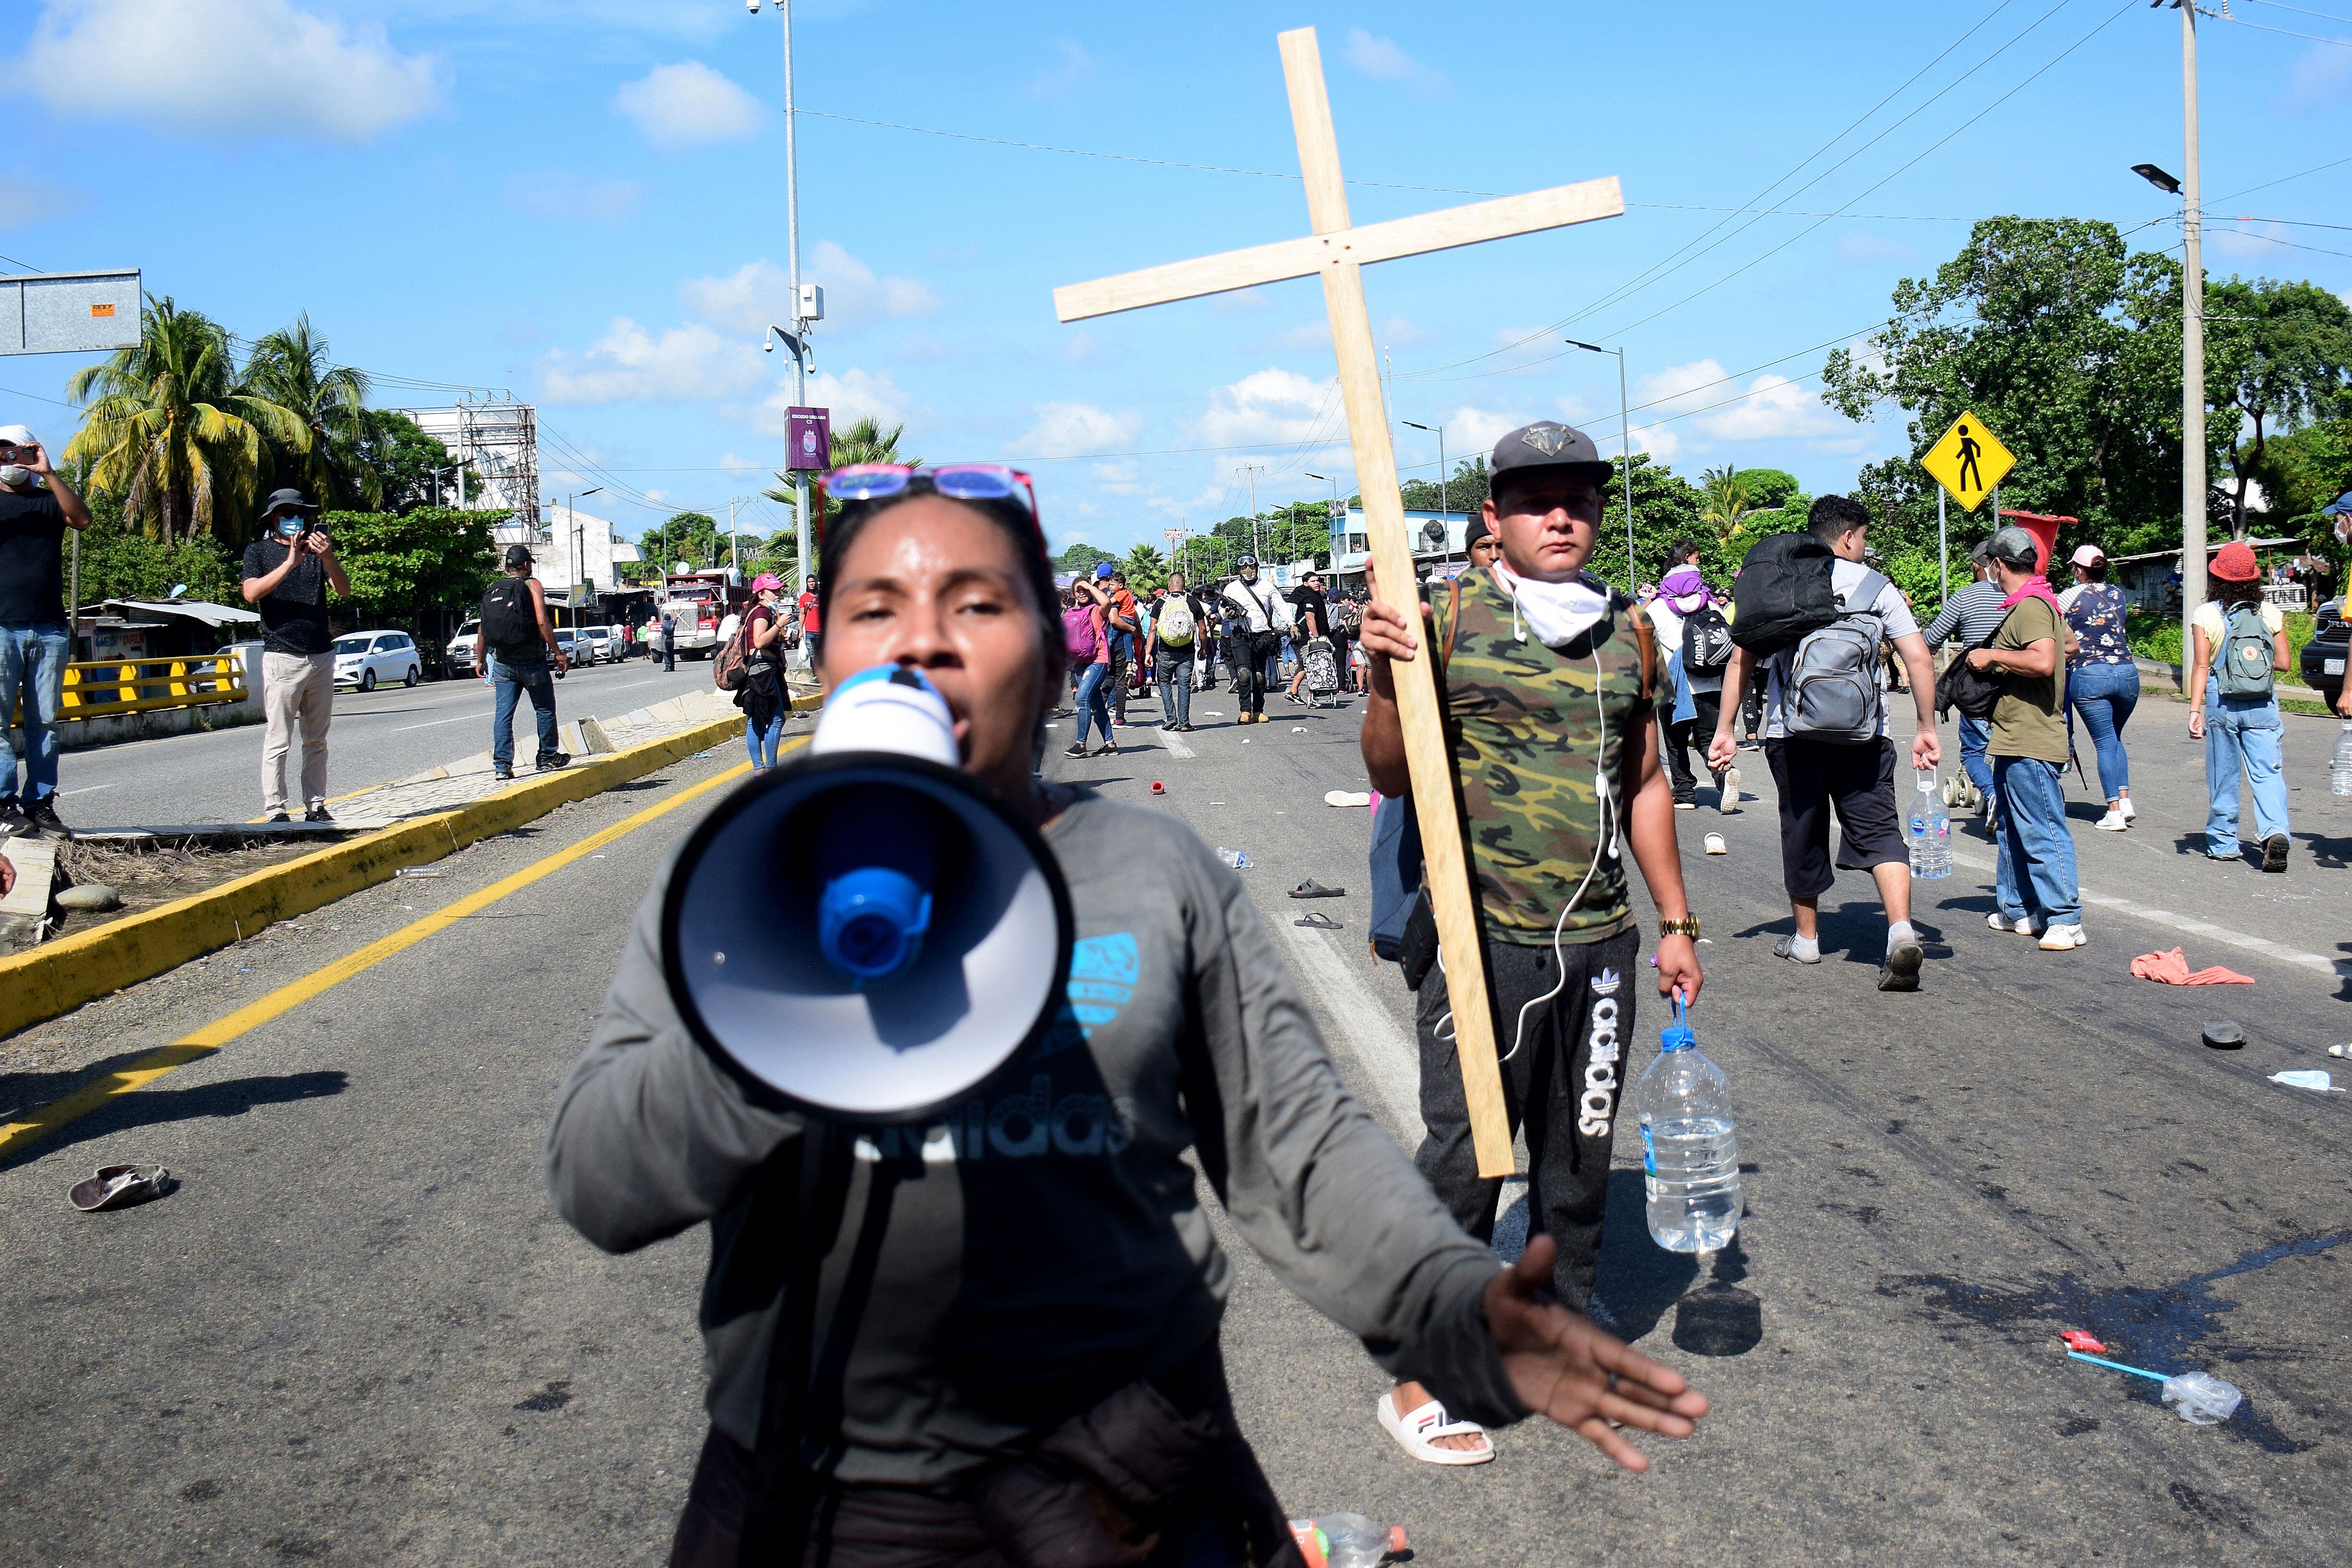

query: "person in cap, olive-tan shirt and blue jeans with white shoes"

left=1966, top=524, right=2086, bottom=952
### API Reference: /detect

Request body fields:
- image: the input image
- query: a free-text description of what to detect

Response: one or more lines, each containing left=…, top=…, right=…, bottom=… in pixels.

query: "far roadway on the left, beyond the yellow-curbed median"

left=57, top=658, right=734, bottom=827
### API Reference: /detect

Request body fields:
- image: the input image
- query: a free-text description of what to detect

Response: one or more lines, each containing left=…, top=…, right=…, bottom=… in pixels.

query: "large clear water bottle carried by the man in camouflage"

left=1632, top=997, right=1741, bottom=1253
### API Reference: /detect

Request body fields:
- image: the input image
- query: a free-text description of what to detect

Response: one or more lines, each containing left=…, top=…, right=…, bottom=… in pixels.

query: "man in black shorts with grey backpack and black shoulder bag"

left=1708, top=496, right=1943, bottom=992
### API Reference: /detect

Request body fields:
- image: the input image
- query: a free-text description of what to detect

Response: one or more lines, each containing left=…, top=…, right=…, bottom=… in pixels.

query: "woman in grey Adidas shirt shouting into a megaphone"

left=546, top=465, right=1708, bottom=1568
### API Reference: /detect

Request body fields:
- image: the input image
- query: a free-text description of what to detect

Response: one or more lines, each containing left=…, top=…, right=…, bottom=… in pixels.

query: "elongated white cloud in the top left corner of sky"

left=21, top=0, right=447, bottom=141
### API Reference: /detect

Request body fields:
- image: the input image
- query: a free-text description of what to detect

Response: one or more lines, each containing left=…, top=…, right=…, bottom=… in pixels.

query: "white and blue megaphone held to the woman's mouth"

left=661, top=665, right=1075, bottom=1124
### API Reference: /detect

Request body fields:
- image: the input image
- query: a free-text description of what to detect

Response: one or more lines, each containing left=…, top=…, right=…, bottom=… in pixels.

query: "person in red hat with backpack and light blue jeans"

left=2190, top=538, right=2291, bottom=872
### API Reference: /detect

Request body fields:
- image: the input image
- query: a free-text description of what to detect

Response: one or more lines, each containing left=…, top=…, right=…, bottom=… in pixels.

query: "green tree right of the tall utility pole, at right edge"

left=2206, top=278, right=2352, bottom=538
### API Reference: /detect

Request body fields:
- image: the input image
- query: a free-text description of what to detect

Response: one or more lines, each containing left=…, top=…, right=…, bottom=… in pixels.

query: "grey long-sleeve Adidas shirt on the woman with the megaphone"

left=546, top=797, right=1527, bottom=1486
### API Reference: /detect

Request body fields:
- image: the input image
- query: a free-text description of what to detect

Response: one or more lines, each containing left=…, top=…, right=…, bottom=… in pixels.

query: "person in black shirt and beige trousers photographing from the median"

left=242, top=489, right=351, bottom=823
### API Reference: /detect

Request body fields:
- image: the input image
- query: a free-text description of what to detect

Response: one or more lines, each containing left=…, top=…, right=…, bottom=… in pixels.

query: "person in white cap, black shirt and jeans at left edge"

left=0, top=425, right=89, bottom=837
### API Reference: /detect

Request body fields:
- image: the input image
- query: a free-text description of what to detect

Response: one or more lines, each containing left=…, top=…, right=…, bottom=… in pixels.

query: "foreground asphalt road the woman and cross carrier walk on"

left=0, top=668, right=2352, bottom=1566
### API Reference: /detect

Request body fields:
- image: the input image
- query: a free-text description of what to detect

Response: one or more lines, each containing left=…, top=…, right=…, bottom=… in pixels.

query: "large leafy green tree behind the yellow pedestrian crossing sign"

left=1825, top=216, right=2182, bottom=555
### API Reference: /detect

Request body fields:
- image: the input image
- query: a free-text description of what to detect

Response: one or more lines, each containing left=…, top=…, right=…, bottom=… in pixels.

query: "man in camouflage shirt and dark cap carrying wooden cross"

left=1362, top=423, right=1700, bottom=1465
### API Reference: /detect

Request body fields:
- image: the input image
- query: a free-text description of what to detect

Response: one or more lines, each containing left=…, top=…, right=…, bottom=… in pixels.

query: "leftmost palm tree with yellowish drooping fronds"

left=66, top=296, right=311, bottom=543
